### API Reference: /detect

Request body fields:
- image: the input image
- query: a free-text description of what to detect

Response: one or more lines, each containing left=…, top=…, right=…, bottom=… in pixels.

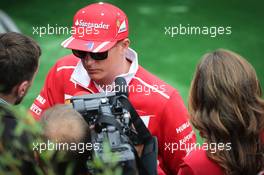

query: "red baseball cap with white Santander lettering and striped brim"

left=61, top=2, right=128, bottom=53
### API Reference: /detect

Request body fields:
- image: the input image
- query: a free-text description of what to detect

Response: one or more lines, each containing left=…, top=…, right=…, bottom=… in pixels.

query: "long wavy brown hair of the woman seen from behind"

left=189, top=49, right=264, bottom=175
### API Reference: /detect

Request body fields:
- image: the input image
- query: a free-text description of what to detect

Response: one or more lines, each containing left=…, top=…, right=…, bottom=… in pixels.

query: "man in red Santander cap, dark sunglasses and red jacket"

left=30, top=3, right=195, bottom=174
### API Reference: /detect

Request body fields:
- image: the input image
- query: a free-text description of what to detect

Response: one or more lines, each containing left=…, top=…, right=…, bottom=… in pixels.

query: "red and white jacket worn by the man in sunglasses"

left=30, top=48, right=196, bottom=175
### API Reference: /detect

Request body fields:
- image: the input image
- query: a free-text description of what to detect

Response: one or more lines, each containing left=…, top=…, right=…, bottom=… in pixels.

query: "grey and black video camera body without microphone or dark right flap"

left=71, top=92, right=136, bottom=174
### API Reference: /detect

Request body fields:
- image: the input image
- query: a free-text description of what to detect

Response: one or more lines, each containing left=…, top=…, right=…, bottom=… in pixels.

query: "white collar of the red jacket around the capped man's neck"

left=71, top=48, right=138, bottom=92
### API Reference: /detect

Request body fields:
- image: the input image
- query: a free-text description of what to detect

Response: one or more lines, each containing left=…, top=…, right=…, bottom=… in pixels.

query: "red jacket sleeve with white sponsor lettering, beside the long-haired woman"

left=159, top=91, right=196, bottom=175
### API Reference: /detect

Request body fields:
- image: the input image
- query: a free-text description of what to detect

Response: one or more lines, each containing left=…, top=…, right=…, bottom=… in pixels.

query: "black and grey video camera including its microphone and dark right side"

left=71, top=77, right=158, bottom=175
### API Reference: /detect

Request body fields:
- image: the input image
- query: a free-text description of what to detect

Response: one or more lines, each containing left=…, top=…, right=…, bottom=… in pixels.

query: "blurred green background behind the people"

left=0, top=0, right=264, bottom=142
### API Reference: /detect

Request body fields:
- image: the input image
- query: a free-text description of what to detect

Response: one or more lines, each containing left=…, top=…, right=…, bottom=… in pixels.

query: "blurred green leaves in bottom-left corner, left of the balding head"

left=0, top=106, right=41, bottom=175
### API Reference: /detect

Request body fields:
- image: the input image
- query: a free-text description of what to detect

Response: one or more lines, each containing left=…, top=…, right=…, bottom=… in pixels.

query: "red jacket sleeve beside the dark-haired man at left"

left=30, top=64, right=64, bottom=120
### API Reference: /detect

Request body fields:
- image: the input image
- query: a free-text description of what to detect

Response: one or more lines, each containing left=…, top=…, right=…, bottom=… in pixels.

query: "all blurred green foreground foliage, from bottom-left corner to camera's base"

left=0, top=107, right=122, bottom=175
